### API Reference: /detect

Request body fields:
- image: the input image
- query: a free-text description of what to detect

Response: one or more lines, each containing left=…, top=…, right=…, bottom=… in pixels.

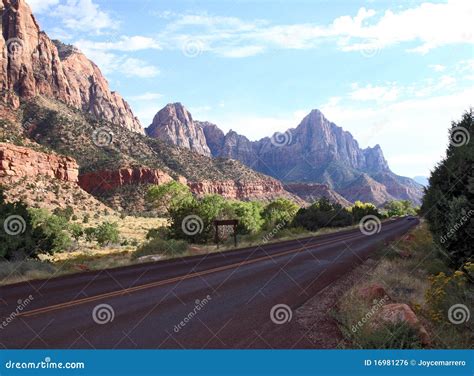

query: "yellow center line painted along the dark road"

left=18, top=233, right=361, bottom=317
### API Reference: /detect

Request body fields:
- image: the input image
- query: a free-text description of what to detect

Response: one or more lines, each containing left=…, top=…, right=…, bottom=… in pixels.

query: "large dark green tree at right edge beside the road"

left=421, top=109, right=474, bottom=267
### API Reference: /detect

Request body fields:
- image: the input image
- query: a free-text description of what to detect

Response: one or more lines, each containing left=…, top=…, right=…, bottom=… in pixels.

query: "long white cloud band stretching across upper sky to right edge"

left=158, top=0, right=474, bottom=57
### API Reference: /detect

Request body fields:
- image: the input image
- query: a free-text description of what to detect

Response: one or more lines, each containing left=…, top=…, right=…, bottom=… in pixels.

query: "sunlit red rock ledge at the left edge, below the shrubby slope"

left=0, top=143, right=79, bottom=183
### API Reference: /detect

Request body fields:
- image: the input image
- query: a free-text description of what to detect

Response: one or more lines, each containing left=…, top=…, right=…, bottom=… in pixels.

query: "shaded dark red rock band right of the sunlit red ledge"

left=79, top=167, right=173, bottom=194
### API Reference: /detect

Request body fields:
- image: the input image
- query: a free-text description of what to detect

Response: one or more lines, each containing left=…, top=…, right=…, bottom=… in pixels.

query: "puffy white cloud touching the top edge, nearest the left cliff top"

left=49, top=0, right=119, bottom=34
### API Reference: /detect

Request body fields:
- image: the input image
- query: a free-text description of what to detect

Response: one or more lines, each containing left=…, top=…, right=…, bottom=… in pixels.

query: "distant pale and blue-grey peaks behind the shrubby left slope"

left=146, top=103, right=422, bottom=205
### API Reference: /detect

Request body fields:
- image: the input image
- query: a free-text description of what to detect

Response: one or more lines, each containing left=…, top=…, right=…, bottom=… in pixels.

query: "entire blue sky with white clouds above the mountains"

left=27, top=0, right=474, bottom=176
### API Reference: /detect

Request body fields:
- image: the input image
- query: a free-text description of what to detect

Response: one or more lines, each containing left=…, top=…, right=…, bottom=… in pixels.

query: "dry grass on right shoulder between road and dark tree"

left=334, top=223, right=472, bottom=349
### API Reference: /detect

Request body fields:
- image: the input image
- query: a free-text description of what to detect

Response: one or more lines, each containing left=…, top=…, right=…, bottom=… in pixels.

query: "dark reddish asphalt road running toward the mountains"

left=0, top=218, right=418, bottom=349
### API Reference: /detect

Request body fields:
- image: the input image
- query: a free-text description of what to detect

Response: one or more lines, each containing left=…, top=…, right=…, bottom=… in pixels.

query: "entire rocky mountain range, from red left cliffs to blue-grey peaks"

left=0, top=0, right=421, bottom=212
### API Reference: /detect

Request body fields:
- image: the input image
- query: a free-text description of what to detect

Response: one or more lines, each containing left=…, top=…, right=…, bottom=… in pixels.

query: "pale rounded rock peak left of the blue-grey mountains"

left=146, top=103, right=211, bottom=156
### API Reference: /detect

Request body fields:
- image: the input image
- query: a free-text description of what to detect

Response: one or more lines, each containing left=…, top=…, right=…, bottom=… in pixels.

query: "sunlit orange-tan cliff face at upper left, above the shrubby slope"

left=0, top=0, right=144, bottom=133
